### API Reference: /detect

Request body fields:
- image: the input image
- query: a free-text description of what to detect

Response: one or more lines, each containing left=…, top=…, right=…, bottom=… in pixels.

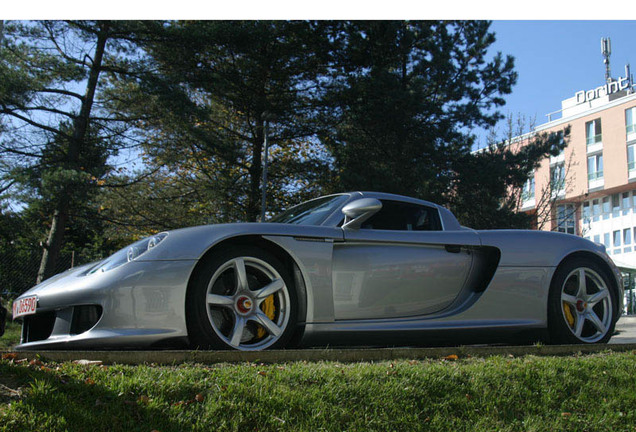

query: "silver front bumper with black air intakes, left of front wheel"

left=16, top=260, right=196, bottom=350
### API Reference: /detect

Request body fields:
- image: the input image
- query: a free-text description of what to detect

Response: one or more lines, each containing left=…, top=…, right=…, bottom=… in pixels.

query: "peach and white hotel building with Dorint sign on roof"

left=519, top=71, right=636, bottom=312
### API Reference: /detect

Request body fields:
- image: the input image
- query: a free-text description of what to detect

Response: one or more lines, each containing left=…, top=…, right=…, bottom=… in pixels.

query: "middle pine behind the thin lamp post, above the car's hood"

left=102, top=21, right=325, bottom=225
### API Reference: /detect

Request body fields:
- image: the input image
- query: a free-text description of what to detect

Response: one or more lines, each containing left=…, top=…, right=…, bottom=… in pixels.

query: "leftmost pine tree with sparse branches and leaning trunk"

left=0, top=21, right=147, bottom=280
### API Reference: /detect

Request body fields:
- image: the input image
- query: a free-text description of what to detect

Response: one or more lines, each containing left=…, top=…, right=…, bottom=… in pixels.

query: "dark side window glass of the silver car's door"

left=362, top=200, right=442, bottom=231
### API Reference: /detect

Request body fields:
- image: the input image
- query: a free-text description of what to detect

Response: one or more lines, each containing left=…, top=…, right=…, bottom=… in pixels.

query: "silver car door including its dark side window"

left=333, top=200, right=480, bottom=320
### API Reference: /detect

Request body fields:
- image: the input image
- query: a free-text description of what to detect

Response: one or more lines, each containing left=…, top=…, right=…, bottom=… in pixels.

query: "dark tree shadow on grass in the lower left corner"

left=0, top=362, right=196, bottom=432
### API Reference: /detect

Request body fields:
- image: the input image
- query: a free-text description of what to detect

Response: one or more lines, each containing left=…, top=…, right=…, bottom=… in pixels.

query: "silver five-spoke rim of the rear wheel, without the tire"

left=561, top=267, right=612, bottom=343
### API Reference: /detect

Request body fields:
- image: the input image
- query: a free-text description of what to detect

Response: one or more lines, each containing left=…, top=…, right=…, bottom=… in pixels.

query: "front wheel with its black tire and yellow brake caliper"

left=186, top=246, right=299, bottom=351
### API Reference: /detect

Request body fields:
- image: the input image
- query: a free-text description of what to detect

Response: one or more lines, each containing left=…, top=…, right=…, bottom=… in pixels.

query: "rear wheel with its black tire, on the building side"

left=548, top=258, right=618, bottom=344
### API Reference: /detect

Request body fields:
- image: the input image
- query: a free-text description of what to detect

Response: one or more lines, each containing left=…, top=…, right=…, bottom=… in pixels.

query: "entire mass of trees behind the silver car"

left=0, top=20, right=568, bottom=283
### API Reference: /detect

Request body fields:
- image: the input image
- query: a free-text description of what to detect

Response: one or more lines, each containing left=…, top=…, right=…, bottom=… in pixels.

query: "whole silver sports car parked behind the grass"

left=13, top=192, right=623, bottom=350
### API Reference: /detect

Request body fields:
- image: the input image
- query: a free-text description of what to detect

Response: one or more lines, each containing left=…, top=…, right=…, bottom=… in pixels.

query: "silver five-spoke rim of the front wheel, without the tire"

left=206, top=256, right=291, bottom=351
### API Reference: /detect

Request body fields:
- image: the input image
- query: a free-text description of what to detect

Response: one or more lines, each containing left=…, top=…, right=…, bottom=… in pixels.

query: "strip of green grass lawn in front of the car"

left=0, top=352, right=636, bottom=432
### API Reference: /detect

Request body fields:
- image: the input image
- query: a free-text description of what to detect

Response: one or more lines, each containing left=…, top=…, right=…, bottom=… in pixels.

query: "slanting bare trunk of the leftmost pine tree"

left=36, top=22, right=108, bottom=283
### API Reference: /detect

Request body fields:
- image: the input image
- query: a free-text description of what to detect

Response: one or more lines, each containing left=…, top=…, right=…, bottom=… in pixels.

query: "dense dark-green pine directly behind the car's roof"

left=323, top=21, right=517, bottom=204
